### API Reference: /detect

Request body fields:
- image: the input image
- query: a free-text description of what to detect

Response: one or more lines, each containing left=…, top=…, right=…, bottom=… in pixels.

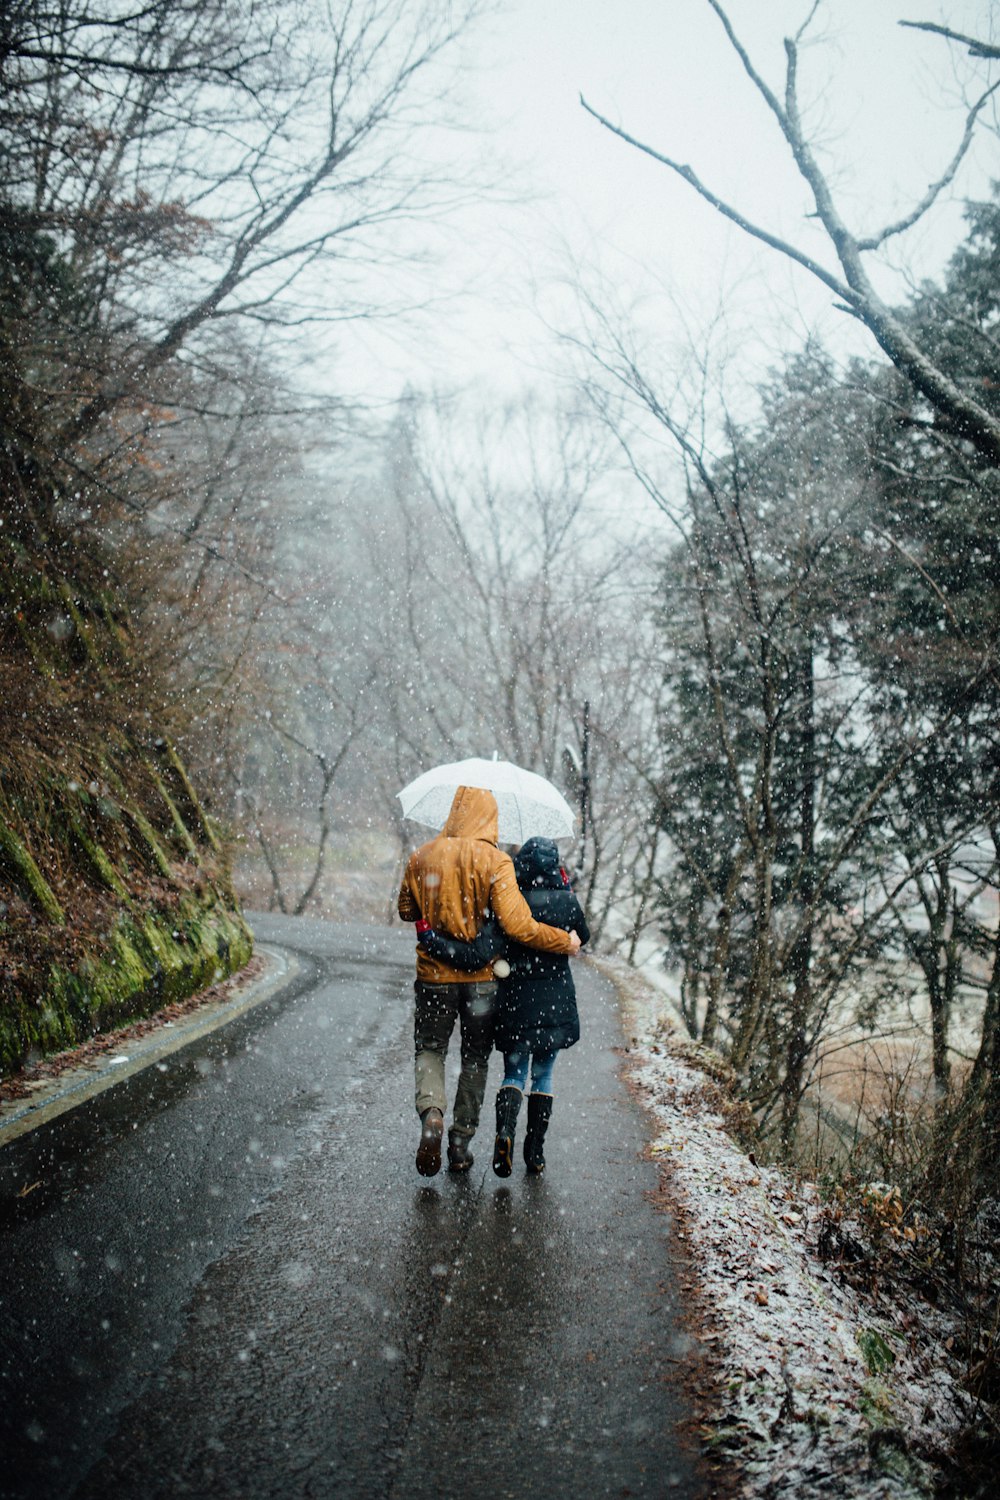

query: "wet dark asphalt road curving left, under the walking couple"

left=0, top=917, right=711, bottom=1500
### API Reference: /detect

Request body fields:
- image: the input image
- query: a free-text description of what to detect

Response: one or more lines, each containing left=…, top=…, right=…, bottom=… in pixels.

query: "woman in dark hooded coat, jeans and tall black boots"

left=418, top=839, right=591, bottom=1178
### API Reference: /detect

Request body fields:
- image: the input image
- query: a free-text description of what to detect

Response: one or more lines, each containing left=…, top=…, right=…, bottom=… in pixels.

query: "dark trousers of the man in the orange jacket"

left=414, top=980, right=496, bottom=1136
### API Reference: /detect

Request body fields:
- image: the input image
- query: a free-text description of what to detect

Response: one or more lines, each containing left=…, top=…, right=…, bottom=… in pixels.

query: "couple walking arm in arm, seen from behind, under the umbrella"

left=399, top=786, right=589, bottom=1178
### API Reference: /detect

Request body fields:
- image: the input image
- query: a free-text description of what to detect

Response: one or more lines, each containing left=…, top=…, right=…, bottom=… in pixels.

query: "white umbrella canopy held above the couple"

left=396, top=756, right=573, bottom=845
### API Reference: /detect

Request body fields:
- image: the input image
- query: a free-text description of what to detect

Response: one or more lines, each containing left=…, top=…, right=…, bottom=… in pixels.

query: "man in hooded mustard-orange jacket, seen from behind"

left=399, top=786, right=580, bottom=1178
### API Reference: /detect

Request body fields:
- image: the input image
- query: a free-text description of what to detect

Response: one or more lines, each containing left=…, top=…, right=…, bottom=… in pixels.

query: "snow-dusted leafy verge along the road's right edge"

left=600, top=960, right=970, bottom=1500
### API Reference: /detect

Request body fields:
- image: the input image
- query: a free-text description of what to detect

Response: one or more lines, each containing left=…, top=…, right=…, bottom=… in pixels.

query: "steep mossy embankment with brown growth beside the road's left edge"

left=0, top=537, right=252, bottom=1073
